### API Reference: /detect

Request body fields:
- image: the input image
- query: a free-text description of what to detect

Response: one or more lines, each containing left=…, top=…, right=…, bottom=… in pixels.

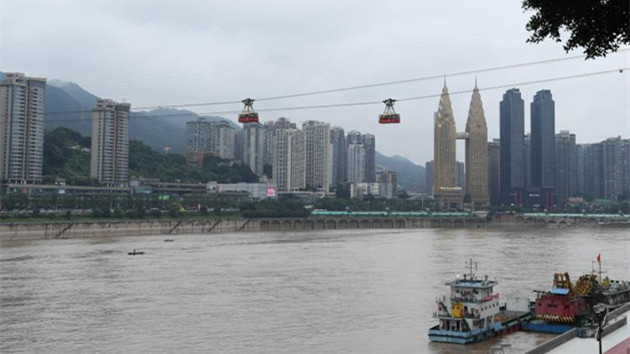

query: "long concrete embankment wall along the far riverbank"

left=0, top=217, right=630, bottom=241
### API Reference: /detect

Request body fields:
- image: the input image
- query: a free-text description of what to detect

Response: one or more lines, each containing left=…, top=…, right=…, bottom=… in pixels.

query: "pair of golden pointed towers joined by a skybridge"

left=433, top=80, right=489, bottom=208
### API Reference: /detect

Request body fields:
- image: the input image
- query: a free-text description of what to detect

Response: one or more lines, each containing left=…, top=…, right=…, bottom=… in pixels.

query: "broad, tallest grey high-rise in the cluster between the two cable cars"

left=302, top=120, right=331, bottom=192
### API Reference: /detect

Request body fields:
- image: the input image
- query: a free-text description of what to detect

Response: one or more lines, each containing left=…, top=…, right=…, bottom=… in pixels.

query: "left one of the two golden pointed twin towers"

left=433, top=83, right=463, bottom=208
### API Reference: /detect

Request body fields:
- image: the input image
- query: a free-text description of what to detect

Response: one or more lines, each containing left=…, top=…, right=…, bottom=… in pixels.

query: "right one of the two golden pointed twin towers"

left=464, top=83, right=488, bottom=207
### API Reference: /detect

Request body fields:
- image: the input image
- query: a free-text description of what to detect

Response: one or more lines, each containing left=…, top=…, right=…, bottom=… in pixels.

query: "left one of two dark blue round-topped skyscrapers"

left=500, top=89, right=525, bottom=205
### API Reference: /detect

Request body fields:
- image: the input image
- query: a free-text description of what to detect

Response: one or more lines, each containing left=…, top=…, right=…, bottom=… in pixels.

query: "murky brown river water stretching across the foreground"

left=0, top=228, right=630, bottom=353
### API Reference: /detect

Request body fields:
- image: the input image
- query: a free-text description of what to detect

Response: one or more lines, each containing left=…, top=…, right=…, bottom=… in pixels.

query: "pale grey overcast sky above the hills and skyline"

left=0, top=0, right=630, bottom=164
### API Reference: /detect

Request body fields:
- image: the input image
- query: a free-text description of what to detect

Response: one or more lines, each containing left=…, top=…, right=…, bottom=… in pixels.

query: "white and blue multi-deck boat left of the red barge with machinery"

left=429, top=259, right=531, bottom=344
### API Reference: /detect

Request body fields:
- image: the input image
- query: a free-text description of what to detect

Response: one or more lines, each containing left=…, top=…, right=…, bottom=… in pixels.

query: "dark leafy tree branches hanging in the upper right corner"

left=523, top=0, right=630, bottom=59
